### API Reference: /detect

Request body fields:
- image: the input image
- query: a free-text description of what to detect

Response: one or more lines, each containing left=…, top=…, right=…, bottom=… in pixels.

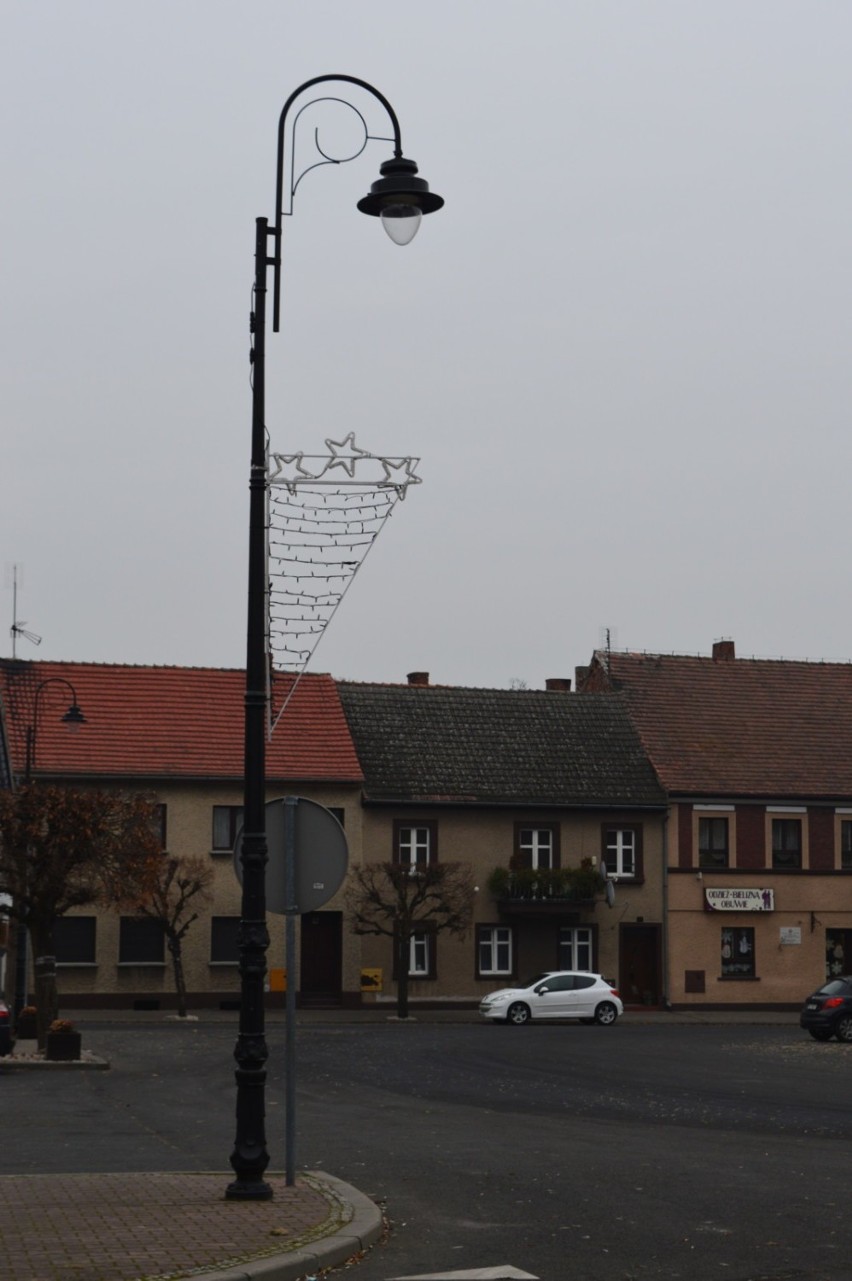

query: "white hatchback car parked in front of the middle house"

left=479, top=970, right=624, bottom=1027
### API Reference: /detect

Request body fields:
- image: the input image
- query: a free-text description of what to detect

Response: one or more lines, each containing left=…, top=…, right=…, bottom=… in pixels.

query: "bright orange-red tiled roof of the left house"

left=0, top=658, right=361, bottom=783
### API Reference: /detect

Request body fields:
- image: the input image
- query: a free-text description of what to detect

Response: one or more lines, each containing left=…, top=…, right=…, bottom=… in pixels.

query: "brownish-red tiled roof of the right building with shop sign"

left=587, top=653, right=852, bottom=799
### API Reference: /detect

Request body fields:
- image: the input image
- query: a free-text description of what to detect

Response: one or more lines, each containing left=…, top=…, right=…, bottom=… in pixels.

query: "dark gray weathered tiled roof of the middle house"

left=337, top=681, right=664, bottom=806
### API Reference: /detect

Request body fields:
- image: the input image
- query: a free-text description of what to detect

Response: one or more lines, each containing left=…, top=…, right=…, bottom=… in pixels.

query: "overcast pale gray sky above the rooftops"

left=0, top=0, right=852, bottom=687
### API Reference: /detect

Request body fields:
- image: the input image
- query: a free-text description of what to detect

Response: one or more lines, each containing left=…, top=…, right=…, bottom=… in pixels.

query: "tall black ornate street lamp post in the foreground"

left=225, top=76, right=443, bottom=1200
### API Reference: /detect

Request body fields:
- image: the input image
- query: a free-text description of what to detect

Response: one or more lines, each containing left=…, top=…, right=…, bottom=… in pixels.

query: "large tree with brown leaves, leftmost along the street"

left=0, top=783, right=159, bottom=1048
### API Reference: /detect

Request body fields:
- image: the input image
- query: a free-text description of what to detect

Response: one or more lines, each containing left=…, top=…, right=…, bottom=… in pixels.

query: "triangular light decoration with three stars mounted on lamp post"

left=266, top=432, right=422, bottom=735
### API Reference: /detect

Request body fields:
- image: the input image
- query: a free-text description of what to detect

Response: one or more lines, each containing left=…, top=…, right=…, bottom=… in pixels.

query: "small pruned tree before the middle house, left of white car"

left=346, top=863, right=475, bottom=1018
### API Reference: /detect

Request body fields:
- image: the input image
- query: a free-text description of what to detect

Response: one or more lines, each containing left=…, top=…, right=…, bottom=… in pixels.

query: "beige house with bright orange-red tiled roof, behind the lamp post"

left=0, top=660, right=361, bottom=1008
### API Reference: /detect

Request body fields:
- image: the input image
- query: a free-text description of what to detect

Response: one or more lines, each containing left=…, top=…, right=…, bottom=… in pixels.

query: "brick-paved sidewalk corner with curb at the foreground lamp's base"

left=0, top=1172, right=382, bottom=1281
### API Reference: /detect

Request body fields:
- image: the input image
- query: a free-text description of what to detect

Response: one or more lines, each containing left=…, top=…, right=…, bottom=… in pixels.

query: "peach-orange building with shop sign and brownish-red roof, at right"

left=577, top=641, right=852, bottom=1008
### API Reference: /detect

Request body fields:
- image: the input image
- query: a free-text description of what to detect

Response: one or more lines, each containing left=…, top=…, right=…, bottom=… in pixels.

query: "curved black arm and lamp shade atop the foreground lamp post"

left=269, top=76, right=443, bottom=333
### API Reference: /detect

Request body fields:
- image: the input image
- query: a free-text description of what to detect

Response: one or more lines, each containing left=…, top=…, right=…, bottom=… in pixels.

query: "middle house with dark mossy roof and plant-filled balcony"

left=337, top=673, right=665, bottom=1004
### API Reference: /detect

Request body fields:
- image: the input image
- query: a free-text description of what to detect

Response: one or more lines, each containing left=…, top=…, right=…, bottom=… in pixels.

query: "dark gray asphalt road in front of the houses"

left=0, top=1018, right=852, bottom=1281
